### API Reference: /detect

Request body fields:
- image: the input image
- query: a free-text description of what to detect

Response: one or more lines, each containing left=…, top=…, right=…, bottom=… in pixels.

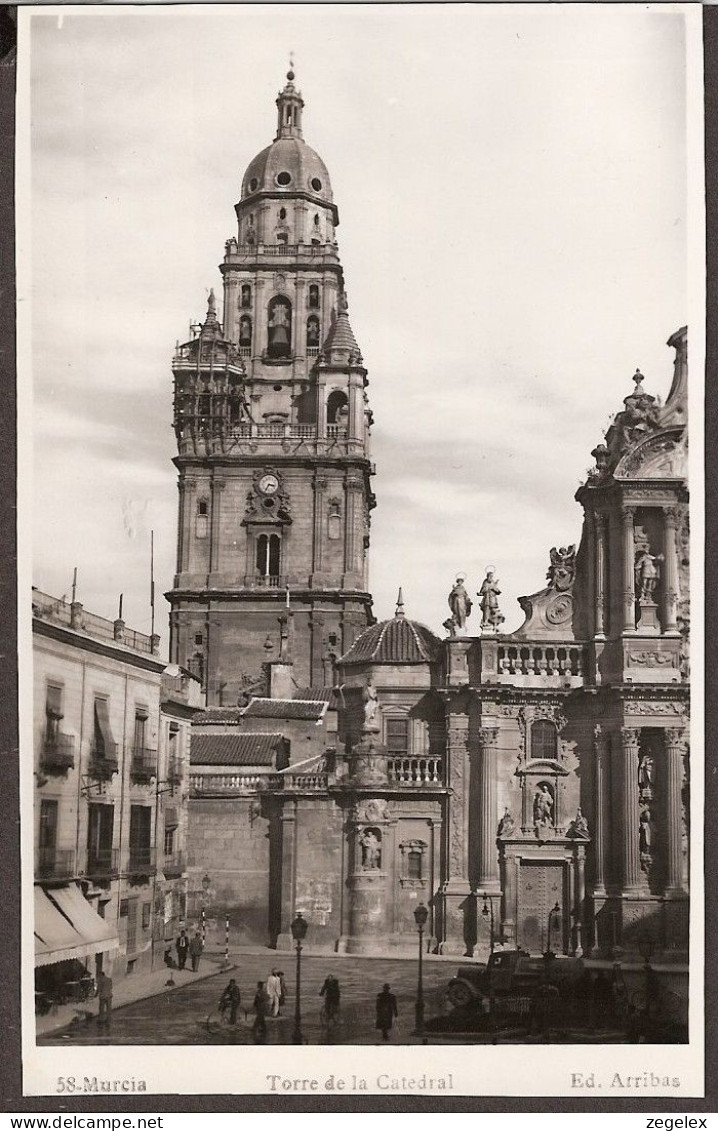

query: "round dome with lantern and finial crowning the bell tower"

left=241, top=71, right=334, bottom=205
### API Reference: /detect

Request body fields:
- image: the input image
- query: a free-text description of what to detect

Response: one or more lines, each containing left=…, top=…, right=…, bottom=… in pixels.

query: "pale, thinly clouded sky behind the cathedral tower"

left=21, top=5, right=687, bottom=647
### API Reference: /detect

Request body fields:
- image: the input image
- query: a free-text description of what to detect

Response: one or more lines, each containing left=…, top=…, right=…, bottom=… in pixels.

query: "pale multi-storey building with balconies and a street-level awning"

left=33, top=589, right=202, bottom=1001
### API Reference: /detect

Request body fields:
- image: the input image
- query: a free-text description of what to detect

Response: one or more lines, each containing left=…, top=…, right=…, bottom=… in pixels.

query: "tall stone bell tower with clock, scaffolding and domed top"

left=167, top=71, right=374, bottom=706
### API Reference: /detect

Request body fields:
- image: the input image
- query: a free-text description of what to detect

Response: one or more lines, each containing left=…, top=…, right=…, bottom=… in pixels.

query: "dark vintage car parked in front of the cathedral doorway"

left=447, top=950, right=583, bottom=1008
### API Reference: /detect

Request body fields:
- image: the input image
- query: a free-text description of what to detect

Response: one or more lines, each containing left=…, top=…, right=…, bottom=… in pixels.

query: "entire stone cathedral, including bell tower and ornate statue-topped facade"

left=167, top=72, right=690, bottom=958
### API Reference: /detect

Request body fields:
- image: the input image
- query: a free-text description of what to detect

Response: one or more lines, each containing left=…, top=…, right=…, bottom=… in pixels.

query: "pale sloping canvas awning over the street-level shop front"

left=35, top=883, right=120, bottom=966
